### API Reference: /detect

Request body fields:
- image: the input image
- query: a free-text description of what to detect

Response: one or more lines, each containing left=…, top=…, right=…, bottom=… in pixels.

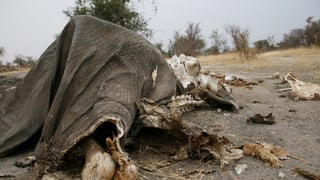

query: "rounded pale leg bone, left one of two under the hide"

left=81, top=136, right=116, bottom=180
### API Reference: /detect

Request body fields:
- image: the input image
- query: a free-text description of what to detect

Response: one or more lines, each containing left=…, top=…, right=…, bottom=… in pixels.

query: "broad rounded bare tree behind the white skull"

left=169, top=23, right=205, bottom=56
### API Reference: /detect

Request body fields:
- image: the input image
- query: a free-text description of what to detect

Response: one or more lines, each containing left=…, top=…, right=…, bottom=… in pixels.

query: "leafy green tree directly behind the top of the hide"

left=63, top=0, right=153, bottom=38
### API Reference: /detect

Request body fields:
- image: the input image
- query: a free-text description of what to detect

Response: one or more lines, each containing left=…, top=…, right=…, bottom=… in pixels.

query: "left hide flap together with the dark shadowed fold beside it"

left=0, top=17, right=86, bottom=156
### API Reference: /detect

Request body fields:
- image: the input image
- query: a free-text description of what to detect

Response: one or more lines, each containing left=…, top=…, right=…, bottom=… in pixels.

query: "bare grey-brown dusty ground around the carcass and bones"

left=0, top=60, right=320, bottom=180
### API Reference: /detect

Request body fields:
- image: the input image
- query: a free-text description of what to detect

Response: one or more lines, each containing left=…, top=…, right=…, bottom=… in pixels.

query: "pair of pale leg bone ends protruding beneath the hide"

left=81, top=134, right=138, bottom=180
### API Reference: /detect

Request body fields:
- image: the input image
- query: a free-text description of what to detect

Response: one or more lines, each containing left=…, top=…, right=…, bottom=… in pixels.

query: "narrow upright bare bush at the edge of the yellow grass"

left=225, top=24, right=250, bottom=57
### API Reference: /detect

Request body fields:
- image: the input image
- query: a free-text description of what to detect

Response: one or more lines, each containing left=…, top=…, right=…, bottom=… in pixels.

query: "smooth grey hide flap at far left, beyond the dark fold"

left=0, top=41, right=58, bottom=156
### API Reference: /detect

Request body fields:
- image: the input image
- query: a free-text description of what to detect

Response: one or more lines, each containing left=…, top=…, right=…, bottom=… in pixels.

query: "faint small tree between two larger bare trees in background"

left=207, top=30, right=229, bottom=54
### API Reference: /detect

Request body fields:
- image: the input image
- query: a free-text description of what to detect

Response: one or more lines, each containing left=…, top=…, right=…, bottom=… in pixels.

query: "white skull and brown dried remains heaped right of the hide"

left=136, top=55, right=246, bottom=170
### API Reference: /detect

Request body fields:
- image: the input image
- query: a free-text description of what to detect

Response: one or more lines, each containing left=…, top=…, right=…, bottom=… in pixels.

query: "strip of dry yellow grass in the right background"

left=198, top=47, right=320, bottom=82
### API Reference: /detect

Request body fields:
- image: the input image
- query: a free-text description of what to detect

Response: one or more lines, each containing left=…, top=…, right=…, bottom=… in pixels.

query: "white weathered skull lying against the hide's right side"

left=167, top=54, right=239, bottom=111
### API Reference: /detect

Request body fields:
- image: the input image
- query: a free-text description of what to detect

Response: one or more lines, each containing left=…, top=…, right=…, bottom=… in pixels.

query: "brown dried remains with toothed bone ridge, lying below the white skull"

left=137, top=96, right=242, bottom=167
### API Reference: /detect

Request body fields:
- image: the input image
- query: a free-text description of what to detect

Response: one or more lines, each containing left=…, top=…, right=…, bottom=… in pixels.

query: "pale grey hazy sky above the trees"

left=0, top=0, right=320, bottom=61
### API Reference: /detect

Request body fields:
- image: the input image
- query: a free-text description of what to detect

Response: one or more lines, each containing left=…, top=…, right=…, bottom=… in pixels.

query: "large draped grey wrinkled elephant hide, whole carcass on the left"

left=0, top=16, right=177, bottom=178
